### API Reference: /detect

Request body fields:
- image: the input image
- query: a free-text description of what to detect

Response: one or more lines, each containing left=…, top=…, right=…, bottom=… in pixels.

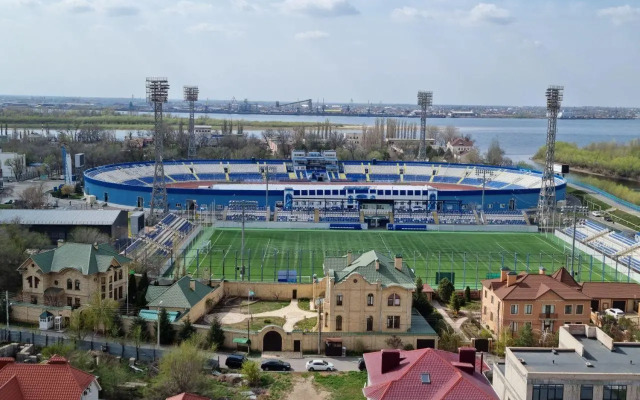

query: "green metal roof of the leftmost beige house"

left=31, top=243, right=131, bottom=275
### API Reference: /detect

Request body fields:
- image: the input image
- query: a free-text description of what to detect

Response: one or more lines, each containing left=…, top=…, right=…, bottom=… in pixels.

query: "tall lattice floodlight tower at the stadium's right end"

left=538, top=86, right=564, bottom=227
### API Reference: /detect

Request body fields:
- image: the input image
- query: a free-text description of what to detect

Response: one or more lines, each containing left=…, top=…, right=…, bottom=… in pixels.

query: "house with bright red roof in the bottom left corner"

left=0, top=356, right=101, bottom=400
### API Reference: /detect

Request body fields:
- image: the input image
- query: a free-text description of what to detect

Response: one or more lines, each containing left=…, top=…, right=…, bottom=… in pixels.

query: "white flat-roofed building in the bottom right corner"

left=493, top=325, right=640, bottom=400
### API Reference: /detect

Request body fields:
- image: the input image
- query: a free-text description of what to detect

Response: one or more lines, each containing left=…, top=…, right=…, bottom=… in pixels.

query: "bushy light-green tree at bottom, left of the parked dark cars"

left=146, top=340, right=207, bottom=399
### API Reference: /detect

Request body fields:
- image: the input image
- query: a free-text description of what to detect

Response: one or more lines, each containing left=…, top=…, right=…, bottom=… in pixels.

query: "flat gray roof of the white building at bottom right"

left=511, top=335, right=640, bottom=376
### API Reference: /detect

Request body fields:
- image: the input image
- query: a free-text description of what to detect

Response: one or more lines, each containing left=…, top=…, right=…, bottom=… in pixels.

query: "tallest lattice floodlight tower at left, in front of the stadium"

left=147, top=78, right=169, bottom=222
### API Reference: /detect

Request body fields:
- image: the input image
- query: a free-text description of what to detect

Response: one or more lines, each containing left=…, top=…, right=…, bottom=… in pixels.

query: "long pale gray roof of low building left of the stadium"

left=0, top=210, right=126, bottom=225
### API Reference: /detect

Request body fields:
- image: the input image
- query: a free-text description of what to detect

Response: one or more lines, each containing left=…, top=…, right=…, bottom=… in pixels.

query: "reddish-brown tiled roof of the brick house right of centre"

left=482, top=268, right=591, bottom=300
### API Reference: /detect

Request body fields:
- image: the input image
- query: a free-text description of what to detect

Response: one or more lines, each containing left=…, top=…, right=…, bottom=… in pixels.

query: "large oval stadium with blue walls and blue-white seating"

left=84, top=151, right=566, bottom=229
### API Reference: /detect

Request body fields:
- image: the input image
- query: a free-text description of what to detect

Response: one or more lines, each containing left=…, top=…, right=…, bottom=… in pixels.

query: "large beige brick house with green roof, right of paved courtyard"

left=320, top=250, right=416, bottom=332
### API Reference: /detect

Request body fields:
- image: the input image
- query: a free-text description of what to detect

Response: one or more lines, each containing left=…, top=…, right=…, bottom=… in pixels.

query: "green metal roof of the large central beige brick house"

left=324, top=250, right=416, bottom=290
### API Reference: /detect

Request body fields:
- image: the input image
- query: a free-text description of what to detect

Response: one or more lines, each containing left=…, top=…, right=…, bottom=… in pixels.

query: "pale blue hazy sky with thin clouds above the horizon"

left=0, top=0, right=640, bottom=107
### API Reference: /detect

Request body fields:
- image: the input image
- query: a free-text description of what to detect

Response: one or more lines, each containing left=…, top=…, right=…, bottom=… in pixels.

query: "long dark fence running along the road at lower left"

left=0, top=328, right=163, bottom=362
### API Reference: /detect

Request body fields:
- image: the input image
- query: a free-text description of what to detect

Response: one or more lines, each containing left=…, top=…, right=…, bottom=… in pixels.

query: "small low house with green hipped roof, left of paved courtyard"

left=146, top=276, right=214, bottom=314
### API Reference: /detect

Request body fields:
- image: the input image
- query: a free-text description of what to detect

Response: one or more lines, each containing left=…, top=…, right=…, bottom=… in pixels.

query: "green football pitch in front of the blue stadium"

left=180, top=228, right=627, bottom=289
